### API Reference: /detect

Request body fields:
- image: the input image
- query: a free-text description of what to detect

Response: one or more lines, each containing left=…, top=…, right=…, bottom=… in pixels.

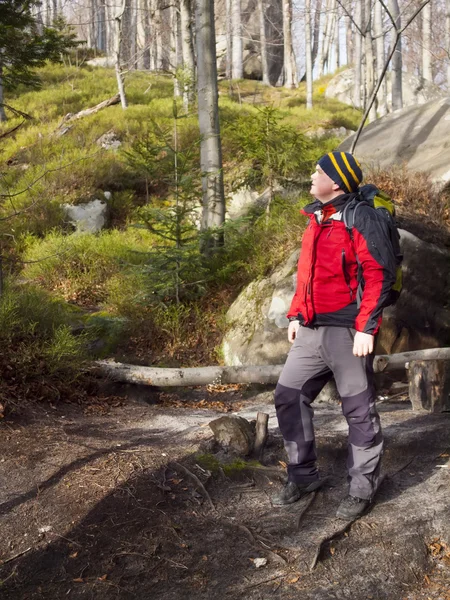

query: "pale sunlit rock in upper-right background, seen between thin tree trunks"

left=325, top=68, right=445, bottom=111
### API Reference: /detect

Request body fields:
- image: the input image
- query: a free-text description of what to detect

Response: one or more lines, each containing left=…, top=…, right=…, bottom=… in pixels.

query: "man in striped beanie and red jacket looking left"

left=273, top=152, right=396, bottom=519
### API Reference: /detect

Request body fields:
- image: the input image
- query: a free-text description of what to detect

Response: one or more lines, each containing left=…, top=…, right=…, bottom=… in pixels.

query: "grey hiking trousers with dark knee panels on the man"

left=275, top=326, right=383, bottom=499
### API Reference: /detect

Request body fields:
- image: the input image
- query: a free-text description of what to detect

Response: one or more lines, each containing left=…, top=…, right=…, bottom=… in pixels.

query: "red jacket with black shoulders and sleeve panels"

left=287, top=194, right=396, bottom=334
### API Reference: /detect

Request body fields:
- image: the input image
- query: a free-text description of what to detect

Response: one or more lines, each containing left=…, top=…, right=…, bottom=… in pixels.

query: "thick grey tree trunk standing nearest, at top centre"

left=195, top=0, right=227, bottom=253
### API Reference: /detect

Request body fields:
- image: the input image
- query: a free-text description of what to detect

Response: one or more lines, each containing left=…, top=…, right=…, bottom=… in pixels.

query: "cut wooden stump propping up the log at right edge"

left=408, top=360, right=450, bottom=412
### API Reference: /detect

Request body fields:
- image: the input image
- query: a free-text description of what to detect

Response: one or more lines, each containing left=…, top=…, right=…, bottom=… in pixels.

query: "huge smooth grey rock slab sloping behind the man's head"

left=339, top=98, right=450, bottom=187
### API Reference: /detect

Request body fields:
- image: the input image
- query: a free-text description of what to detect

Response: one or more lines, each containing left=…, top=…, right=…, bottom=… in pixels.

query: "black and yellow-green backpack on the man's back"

left=342, top=184, right=403, bottom=306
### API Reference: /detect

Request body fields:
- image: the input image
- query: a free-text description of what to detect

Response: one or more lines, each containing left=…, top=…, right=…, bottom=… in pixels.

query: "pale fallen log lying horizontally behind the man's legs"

left=95, top=348, right=450, bottom=387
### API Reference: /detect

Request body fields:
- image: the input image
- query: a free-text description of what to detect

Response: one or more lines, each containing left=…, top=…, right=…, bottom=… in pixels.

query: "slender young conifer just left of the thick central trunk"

left=128, top=100, right=205, bottom=304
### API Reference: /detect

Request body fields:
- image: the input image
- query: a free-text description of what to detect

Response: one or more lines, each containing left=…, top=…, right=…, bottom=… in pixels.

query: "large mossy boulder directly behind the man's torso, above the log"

left=222, top=231, right=450, bottom=365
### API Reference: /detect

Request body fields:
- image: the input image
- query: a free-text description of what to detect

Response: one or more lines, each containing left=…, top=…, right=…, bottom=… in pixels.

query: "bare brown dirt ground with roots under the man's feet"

left=0, top=388, right=450, bottom=600
